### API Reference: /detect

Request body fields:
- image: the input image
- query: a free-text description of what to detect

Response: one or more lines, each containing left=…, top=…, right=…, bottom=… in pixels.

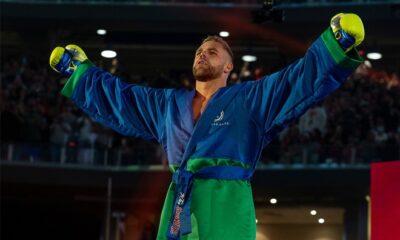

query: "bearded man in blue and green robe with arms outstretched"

left=50, top=14, right=364, bottom=240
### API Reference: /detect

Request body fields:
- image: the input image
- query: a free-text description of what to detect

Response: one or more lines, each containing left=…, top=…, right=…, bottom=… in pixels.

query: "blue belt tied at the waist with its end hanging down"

left=167, top=166, right=252, bottom=240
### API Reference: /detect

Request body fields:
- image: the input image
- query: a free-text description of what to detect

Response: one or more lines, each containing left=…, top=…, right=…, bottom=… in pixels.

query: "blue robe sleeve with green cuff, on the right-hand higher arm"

left=244, top=28, right=362, bottom=140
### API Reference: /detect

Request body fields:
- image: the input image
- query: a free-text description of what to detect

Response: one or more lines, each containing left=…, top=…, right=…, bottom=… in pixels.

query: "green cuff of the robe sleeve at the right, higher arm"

left=321, top=28, right=363, bottom=70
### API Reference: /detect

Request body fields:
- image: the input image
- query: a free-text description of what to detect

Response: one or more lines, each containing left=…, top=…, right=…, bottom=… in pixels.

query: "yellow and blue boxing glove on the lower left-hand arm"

left=49, top=44, right=88, bottom=77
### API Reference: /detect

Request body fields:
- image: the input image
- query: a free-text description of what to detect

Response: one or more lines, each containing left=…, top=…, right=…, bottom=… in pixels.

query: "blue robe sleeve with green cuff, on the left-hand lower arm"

left=61, top=61, right=169, bottom=141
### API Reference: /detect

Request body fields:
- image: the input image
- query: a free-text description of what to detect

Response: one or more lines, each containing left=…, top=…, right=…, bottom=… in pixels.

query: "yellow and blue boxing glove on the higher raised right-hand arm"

left=331, top=13, right=365, bottom=52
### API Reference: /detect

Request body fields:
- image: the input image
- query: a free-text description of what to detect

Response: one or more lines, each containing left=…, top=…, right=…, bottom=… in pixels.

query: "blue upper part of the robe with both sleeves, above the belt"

left=63, top=29, right=361, bottom=169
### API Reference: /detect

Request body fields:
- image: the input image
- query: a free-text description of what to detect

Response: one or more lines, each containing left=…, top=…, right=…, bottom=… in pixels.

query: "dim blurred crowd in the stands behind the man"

left=0, top=57, right=400, bottom=167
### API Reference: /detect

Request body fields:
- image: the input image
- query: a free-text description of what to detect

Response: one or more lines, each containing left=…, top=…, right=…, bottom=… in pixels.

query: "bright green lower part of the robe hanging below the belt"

left=157, top=179, right=256, bottom=240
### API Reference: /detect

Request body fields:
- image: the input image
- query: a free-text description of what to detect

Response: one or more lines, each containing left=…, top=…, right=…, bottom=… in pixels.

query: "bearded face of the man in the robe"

left=192, top=41, right=232, bottom=82
